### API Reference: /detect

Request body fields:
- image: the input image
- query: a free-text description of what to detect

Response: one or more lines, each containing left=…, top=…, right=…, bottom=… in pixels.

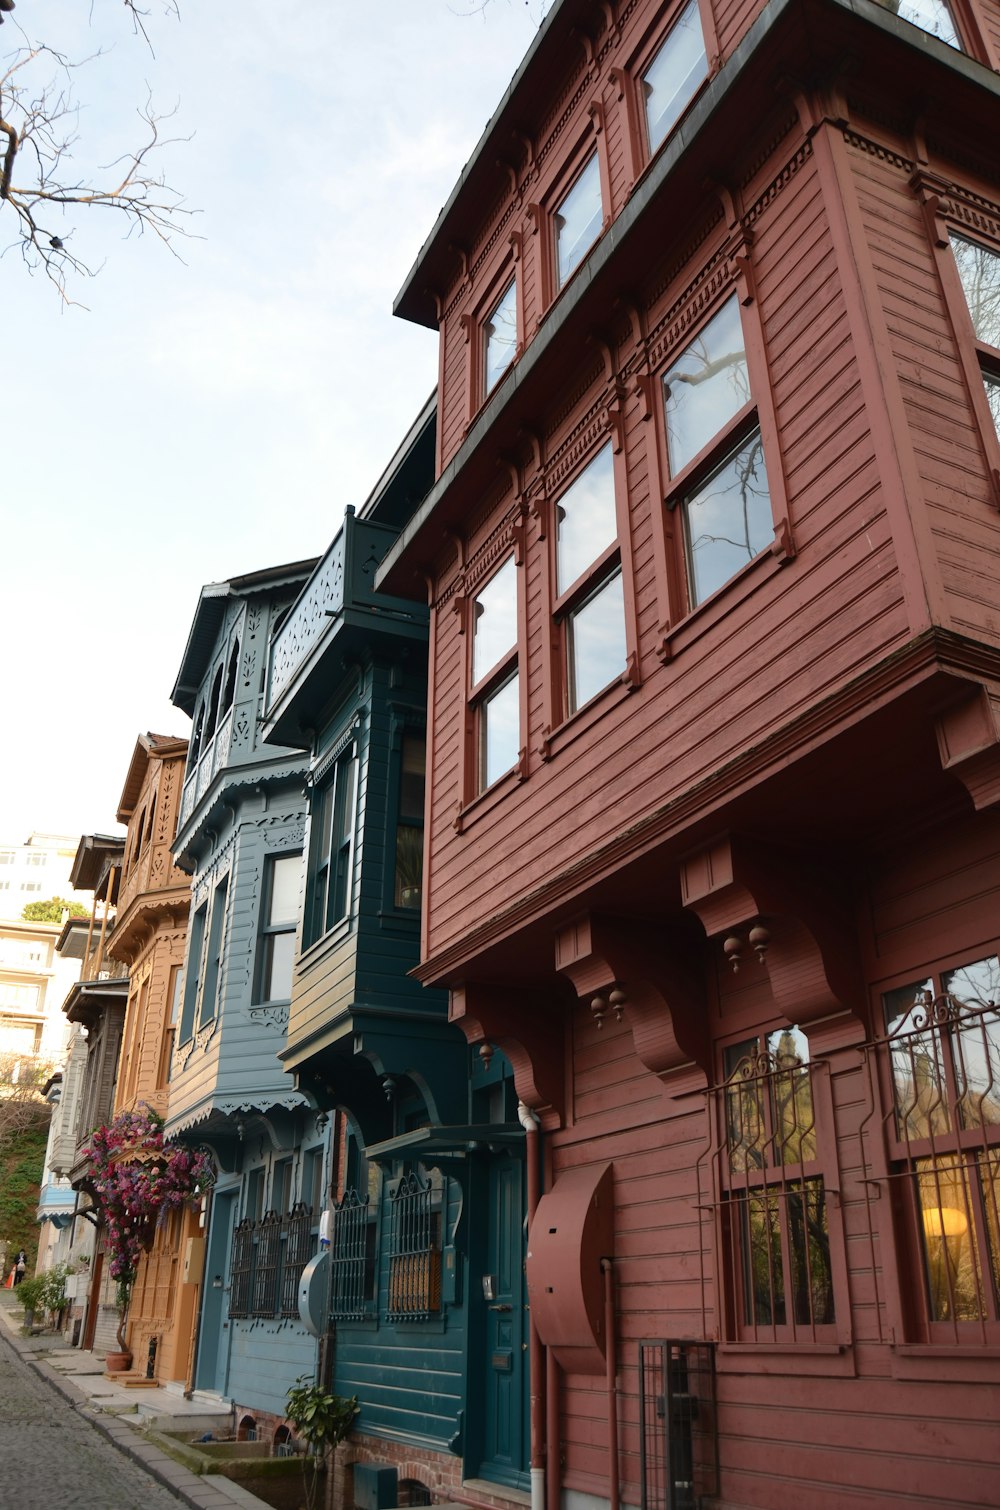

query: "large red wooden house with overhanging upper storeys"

left=379, top=0, right=1000, bottom=1510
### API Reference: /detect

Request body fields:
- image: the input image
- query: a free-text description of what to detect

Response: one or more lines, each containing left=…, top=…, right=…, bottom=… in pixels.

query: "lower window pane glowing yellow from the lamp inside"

left=917, top=1160, right=985, bottom=1321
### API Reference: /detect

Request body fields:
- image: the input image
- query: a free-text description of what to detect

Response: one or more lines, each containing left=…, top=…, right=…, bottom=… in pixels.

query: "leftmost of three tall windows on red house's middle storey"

left=471, top=556, right=521, bottom=791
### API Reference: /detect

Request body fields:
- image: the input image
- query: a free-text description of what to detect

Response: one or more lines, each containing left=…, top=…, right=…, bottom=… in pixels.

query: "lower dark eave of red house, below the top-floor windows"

left=376, top=0, right=1000, bottom=601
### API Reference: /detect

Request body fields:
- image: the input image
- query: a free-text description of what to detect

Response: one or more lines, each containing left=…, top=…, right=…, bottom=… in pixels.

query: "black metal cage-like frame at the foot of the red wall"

left=639, top=1341, right=719, bottom=1510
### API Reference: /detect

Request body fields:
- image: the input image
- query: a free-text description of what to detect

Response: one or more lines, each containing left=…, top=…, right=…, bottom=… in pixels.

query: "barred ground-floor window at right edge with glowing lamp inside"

left=882, top=954, right=1000, bottom=1342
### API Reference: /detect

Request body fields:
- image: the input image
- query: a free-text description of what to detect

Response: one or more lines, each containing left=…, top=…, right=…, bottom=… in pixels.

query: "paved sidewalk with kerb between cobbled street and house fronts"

left=0, top=1290, right=270, bottom=1510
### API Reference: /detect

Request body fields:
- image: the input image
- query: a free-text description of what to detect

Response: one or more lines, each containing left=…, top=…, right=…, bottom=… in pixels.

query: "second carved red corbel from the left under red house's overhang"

left=554, top=914, right=711, bottom=1096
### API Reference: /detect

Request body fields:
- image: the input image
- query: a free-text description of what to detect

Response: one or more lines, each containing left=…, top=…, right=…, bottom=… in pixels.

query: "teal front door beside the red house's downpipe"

left=479, top=1157, right=529, bottom=1489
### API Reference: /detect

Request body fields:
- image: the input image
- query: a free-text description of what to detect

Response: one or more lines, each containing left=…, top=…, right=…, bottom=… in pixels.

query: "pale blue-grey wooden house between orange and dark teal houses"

left=168, top=562, right=328, bottom=1425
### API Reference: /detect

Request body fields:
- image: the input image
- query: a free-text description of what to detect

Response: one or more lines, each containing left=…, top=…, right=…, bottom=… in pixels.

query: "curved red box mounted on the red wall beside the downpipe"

left=527, top=1164, right=615, bottom=1374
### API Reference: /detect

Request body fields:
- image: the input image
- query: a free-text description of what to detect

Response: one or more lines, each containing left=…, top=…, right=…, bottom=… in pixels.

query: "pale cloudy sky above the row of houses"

left=0, top=0, right=545, bottom=843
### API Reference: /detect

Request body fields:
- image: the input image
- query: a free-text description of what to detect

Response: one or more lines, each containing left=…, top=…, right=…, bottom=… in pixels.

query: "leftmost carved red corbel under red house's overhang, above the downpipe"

left=449, top=982, right=568, bottom=1129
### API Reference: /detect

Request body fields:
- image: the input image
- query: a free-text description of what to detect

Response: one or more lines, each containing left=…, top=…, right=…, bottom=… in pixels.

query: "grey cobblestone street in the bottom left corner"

left=0, top=1333, right=184, bottom=1510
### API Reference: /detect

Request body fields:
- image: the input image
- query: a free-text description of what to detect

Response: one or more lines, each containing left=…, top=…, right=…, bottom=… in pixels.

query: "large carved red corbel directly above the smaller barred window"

left=681, top=835, right=867, bottom=1046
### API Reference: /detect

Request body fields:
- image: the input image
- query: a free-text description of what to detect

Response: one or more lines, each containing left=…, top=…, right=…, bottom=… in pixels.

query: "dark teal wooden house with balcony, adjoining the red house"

left=264, top=400, right=527, bottom=1502
